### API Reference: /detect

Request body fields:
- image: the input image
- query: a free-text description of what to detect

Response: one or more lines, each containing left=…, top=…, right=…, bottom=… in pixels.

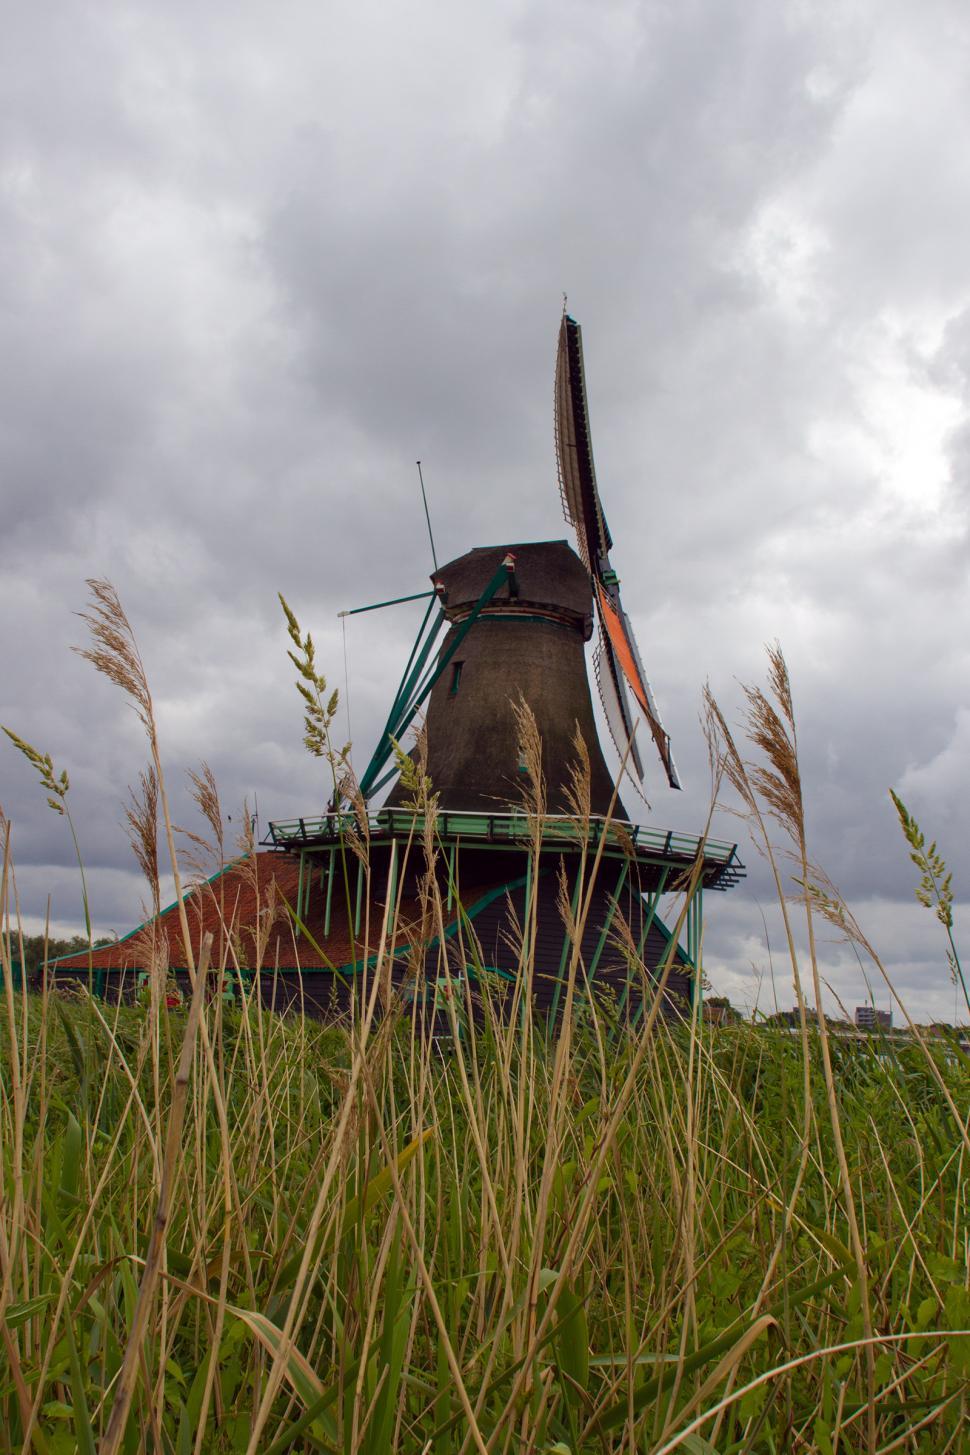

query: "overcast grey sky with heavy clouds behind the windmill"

left=0, top=0, right=970, bottom=1019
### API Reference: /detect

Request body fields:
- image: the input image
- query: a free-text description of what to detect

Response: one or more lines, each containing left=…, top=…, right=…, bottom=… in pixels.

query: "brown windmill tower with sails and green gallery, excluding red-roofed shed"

left=253, top=313, right=743, bottom=1014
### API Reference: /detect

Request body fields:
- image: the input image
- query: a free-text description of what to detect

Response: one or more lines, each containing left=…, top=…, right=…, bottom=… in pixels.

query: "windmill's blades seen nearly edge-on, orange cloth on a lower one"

left=556, top=313, right=681, bottom=789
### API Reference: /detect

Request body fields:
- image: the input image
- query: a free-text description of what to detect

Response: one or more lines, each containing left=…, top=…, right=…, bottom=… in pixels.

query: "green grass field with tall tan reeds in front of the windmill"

left=0, top=594, right=970, bottom=1455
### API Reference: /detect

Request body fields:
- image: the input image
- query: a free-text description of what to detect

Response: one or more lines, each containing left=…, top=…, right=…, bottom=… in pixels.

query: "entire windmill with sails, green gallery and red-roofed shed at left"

left=58, top=313, right=743, bottom=1020
